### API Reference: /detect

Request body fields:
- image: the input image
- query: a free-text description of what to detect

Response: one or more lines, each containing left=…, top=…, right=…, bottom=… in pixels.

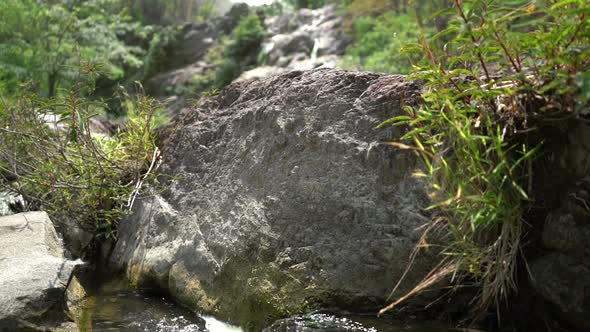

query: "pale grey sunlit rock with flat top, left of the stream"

left=0, top=212, right=74, bottom=331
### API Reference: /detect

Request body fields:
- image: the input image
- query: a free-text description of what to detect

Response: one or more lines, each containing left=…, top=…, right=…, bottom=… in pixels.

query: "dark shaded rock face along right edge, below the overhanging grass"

left=529, top=122, right=590, bottom=331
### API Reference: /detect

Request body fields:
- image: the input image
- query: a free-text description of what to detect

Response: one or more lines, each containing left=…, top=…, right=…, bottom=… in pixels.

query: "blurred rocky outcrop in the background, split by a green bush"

left=143, top=3, right=351, bottom=114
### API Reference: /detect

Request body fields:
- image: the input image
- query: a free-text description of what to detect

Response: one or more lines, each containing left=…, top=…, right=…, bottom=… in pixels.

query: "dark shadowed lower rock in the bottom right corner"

left=530, top=190, right=590, bottom=331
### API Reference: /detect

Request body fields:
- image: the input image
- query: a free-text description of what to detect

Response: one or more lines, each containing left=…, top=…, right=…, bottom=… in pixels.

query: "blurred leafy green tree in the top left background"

left=0, top=0, right=142, bottom=96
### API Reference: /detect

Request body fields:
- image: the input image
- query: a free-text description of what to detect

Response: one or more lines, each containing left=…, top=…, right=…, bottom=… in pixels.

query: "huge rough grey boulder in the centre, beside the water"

left=111, top=70, right=429, bottom=331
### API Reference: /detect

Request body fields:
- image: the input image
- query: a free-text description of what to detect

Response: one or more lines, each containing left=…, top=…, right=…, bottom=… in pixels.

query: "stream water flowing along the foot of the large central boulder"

left=78, top=279, right=480, bottom=332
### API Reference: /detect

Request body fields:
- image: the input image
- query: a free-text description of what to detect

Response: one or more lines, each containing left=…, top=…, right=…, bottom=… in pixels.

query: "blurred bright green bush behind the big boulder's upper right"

left=341, top=0, right=450, bottom=74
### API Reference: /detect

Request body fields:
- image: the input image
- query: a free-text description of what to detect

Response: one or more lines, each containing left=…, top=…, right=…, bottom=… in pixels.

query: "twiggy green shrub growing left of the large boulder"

left=0, top=70, right=159, bottom=237
